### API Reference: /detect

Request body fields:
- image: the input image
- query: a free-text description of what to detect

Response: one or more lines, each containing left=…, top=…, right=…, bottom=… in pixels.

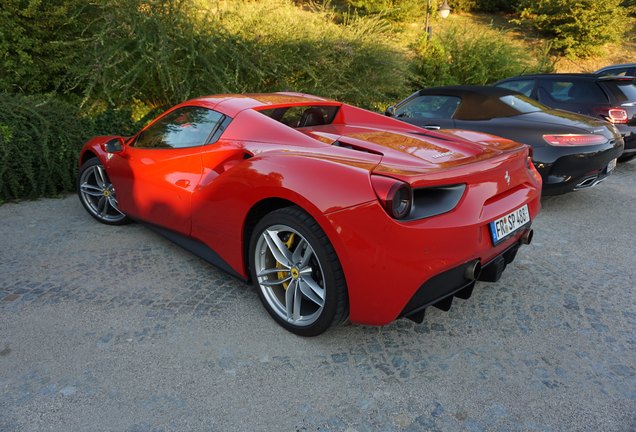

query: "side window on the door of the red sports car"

left=133, top=107, right=223, bottom=149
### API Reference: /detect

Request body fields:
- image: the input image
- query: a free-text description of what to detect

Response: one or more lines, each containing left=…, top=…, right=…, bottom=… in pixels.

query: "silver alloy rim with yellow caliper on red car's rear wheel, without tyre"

left=254, top=225, right=326, bottom=327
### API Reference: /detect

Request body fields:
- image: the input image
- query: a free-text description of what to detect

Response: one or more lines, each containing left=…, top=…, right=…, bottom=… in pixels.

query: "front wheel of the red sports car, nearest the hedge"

left=79, top=164, right=126, bottom=223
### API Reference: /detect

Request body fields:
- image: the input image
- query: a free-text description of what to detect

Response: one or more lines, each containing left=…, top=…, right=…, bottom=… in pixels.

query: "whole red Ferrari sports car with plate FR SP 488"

left=77, top=93, right=541, bottom=336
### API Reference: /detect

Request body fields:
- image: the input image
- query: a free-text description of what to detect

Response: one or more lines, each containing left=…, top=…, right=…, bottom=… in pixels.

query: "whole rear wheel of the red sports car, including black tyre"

left=249, top=207, right=348, bottom=336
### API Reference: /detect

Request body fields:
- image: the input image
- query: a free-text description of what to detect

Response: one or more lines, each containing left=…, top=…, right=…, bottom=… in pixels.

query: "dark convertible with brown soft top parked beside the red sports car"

left=386, top=86, right=624, bottom=195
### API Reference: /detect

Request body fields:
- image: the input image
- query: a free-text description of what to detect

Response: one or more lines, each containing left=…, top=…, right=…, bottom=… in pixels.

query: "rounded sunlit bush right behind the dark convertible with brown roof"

left=413, top=25, right=553, bottom=87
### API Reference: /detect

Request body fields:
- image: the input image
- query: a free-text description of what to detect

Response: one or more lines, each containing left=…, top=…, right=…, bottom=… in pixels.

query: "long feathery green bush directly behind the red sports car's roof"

left=66, top=0, right=407, bottom=107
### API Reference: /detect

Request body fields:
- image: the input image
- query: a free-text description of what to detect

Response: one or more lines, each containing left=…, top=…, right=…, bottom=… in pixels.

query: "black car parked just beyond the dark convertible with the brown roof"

left=495, top=74, right=636, bottom=162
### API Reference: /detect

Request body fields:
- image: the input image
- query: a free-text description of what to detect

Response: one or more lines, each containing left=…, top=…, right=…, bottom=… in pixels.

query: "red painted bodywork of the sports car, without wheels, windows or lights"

left=81, top=93, right=541, bottom=324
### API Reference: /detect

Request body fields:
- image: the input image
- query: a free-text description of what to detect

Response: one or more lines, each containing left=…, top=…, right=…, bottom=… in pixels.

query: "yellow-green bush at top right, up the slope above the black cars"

left=517, top=0, right=628, bottom=57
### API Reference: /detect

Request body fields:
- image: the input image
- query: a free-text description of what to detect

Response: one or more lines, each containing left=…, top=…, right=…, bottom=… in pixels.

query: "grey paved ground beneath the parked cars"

left=0, top=162, right=636, bottom=432
